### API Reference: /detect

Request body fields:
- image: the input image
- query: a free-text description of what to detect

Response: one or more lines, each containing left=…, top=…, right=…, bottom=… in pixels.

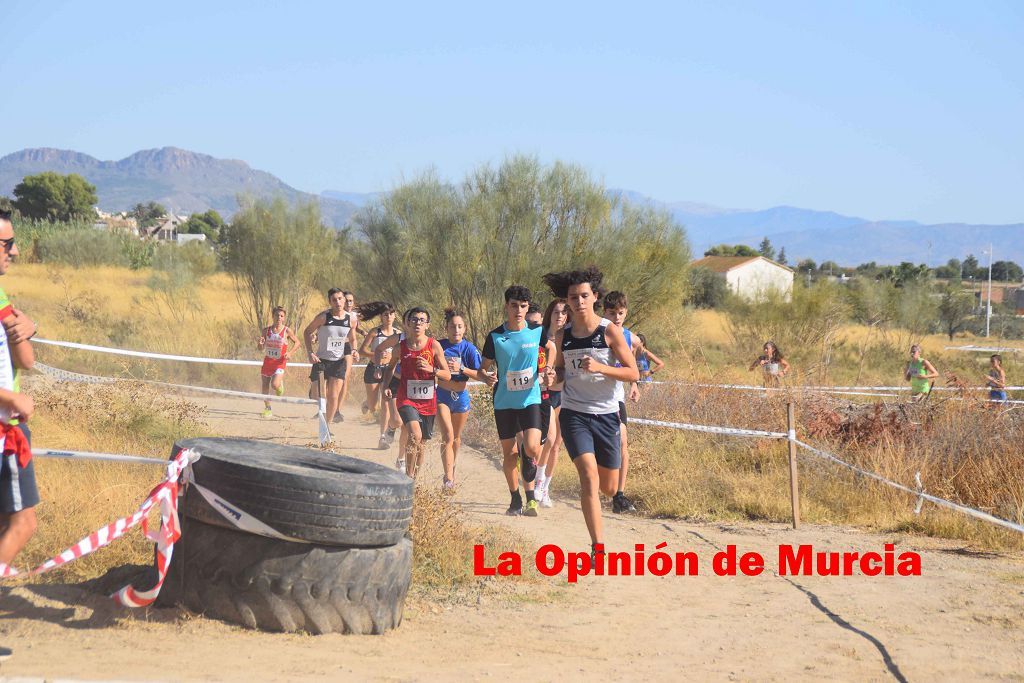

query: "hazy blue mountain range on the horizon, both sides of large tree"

left=0, top=147, right=1024, bottom=265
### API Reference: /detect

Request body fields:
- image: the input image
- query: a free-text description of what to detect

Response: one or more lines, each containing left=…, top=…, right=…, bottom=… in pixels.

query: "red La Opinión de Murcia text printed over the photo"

left=473, top=543, right=921, bottom=584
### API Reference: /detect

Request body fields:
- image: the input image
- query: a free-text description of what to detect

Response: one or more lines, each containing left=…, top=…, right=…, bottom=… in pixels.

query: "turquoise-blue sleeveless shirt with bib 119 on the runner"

left=483, top=323, right=548, bottom=411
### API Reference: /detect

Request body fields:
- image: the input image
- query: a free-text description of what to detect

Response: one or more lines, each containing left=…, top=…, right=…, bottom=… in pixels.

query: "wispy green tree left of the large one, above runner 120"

left=221, top=198, right=338, bottom=328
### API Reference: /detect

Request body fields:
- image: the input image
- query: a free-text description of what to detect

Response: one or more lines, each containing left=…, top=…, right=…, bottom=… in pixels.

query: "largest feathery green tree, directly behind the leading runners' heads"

left=352, top=156, right=690, bottom=339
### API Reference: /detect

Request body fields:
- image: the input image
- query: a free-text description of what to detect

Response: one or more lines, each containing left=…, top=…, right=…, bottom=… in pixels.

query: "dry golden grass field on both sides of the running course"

left=3, top=264, right=1024, bottom=586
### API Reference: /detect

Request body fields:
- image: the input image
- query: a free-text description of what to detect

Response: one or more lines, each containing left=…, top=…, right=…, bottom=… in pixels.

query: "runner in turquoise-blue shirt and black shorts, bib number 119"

left=481, top=285, right=554, bottom=517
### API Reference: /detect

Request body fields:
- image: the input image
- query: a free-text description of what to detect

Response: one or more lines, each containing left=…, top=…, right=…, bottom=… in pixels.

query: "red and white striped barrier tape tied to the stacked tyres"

left=0, top=450, right=200, bottom=607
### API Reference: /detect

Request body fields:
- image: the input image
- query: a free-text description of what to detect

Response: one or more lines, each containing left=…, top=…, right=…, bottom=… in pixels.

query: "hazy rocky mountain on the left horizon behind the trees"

left=0, top=147, right=356, bottom=227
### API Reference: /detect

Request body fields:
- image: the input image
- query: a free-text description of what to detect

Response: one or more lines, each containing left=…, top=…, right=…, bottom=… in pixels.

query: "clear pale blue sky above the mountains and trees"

left=0, top=0, right=1024, bottom=223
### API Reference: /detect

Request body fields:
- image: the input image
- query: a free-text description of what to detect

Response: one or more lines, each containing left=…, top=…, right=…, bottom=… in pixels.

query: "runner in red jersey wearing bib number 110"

left=381, top=306, right=452, bottom=479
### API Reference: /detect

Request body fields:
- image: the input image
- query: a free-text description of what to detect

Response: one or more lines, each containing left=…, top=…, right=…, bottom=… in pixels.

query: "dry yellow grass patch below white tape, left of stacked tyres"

left=18, top=377, right=206, bottom=582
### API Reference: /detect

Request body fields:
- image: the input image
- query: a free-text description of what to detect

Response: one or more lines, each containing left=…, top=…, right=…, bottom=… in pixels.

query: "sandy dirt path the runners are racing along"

left=0, top=399, right=1024, bottom=681
